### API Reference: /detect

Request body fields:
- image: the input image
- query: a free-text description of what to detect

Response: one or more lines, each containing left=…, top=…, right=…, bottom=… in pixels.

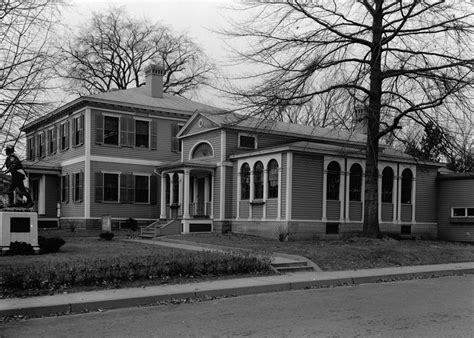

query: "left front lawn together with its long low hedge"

left=0, top=230, right=272, bottom=298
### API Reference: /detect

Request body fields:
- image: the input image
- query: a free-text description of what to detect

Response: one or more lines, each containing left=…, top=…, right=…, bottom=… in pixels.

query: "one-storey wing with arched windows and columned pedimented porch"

left=157, top=111, right=440, bottom=239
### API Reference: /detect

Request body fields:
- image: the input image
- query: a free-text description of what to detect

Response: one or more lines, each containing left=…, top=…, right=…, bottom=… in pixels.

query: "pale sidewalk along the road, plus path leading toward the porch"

left=0, top=240, right=474, bottom=316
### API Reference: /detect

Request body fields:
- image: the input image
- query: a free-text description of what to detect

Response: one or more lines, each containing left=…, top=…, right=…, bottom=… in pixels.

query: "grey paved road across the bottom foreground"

left=0, top=275, right=474, bottom=337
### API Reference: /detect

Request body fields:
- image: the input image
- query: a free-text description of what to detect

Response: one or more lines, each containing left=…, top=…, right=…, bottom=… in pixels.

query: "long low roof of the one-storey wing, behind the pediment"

left=182, top=108, right=366, bottom=145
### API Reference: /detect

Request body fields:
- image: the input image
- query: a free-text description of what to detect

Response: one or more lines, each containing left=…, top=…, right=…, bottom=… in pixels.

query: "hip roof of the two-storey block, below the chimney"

left=22, top=86, right=216, bottom=130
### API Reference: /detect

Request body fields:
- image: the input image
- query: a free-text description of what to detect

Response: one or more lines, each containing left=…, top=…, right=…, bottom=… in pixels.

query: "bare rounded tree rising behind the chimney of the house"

left=58, top=7, right=213, bottom=96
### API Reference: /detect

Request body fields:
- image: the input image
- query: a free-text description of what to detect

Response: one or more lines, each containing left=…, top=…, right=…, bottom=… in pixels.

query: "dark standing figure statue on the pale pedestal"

left=3, top=144, right=34, bottom=208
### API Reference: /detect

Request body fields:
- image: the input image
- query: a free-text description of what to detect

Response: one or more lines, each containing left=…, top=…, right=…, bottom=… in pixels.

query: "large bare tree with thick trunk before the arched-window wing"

left=225, top=0, right=473, bottom=237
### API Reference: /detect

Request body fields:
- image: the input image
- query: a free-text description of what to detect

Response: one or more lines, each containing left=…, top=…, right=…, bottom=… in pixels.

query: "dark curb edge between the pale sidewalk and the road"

left=0, top=267, right=474, bottom=317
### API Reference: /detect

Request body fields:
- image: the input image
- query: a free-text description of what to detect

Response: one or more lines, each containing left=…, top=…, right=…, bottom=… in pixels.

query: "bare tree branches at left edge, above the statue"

left=0, top=0, right=60, bottom=153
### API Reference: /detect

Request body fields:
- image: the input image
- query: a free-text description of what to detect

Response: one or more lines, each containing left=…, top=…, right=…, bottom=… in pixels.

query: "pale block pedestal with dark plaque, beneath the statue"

left=0, top=208, right=39, bottom=254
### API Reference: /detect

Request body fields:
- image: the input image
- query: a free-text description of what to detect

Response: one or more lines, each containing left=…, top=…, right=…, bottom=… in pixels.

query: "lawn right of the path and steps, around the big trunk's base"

left=164, top=233, right=474, bottom=271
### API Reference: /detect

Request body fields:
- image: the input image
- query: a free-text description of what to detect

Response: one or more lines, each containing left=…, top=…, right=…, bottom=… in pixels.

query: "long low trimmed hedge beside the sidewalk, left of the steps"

left=0, top=252, right=271, bottom=295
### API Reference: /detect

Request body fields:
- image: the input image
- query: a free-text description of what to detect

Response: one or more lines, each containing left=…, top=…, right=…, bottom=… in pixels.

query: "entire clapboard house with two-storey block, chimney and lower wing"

left=23, top=66, right=474, bottom=241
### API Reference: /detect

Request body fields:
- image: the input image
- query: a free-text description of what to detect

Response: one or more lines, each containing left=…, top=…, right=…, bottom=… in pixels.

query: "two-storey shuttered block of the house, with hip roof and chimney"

left=23, top=65, right=212, bottom=228
